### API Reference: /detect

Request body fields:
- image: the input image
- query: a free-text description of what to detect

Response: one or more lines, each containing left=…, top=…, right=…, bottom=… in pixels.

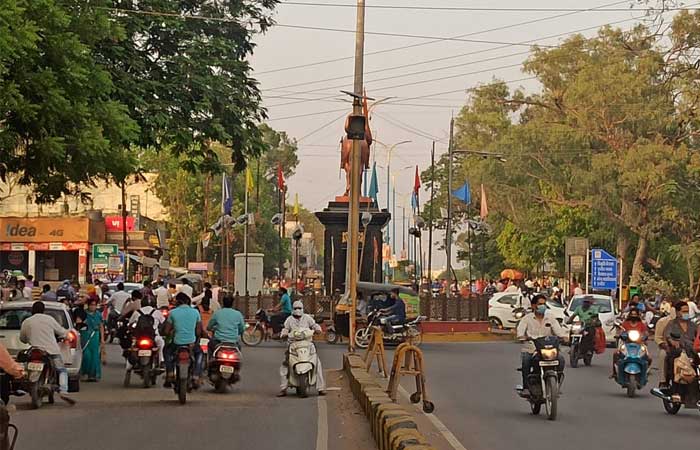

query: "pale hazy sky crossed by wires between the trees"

left=251, top=0, right=668, bottom=267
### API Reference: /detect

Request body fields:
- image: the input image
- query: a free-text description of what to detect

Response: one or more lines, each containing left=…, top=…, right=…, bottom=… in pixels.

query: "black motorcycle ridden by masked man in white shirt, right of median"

left=515, top=336, right=564, bottom=420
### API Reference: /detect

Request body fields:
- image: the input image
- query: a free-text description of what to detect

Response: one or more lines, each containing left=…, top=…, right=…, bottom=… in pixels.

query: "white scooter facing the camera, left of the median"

left=287, top=328, right=318, bottom=398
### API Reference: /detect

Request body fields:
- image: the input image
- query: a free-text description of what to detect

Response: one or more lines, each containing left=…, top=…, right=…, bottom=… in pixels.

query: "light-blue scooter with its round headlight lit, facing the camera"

left=615, top=330, right=648, bottom=398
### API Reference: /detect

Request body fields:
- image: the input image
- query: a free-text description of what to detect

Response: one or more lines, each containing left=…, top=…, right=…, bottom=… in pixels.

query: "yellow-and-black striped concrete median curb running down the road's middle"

left=343, top=353, right=435, bottom=450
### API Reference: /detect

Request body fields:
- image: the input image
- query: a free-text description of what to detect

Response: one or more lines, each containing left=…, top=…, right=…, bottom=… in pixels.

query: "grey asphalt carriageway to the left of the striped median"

left=11, top=342, right=350, bottom=450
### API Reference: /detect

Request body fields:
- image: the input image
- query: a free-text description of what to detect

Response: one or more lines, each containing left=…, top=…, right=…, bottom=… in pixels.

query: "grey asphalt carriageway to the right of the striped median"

left=416, top=343, right=700, bottom=450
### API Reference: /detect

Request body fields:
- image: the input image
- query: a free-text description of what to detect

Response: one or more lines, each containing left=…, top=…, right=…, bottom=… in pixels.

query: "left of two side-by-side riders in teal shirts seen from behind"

left=164, top=292, right=205, bottom=387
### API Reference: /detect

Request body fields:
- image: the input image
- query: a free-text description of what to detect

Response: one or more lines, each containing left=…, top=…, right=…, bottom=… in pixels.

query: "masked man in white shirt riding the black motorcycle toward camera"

left=517, top=294, right=569, bottom=395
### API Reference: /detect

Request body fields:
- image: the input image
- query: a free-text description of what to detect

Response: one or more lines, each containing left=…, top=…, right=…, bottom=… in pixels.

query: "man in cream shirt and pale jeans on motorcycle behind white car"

left=19, top=301, right=75, bottom=405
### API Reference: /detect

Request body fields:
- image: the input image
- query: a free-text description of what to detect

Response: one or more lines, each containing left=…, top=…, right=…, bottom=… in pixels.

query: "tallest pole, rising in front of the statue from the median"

left=346, top=0, right=365, bottom=352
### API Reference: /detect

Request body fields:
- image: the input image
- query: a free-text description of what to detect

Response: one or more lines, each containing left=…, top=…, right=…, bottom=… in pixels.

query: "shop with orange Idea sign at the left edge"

left=0, top=217, right=105, bottom=284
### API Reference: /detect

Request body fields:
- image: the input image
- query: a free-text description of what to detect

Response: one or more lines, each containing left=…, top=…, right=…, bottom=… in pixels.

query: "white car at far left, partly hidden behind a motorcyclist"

left=0, top=301, right=83, bottom=392
